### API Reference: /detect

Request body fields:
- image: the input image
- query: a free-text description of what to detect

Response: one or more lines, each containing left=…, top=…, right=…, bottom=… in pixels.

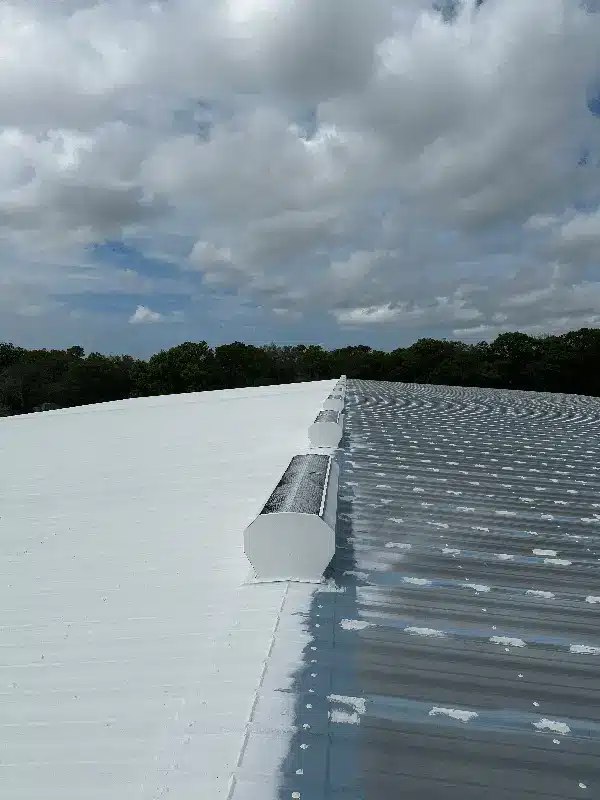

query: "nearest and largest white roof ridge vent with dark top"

left=244, top=453, right=339, bottom=581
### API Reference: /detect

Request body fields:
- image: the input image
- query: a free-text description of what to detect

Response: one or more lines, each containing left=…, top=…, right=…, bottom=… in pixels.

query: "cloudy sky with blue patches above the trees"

left=0, top=0, right=600, bottom=357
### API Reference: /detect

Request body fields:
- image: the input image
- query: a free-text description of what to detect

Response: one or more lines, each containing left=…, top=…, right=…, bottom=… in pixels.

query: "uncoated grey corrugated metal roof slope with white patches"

left=274, top=381, right=600, bottom=800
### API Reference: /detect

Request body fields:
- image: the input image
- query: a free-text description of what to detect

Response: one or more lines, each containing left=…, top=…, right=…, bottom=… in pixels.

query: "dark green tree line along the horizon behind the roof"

left=0, top=328, right=600, bottom=416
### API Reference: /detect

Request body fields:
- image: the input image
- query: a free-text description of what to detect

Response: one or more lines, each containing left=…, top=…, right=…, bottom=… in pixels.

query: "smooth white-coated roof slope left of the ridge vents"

left=0, top=381, right=335, bottom=800
